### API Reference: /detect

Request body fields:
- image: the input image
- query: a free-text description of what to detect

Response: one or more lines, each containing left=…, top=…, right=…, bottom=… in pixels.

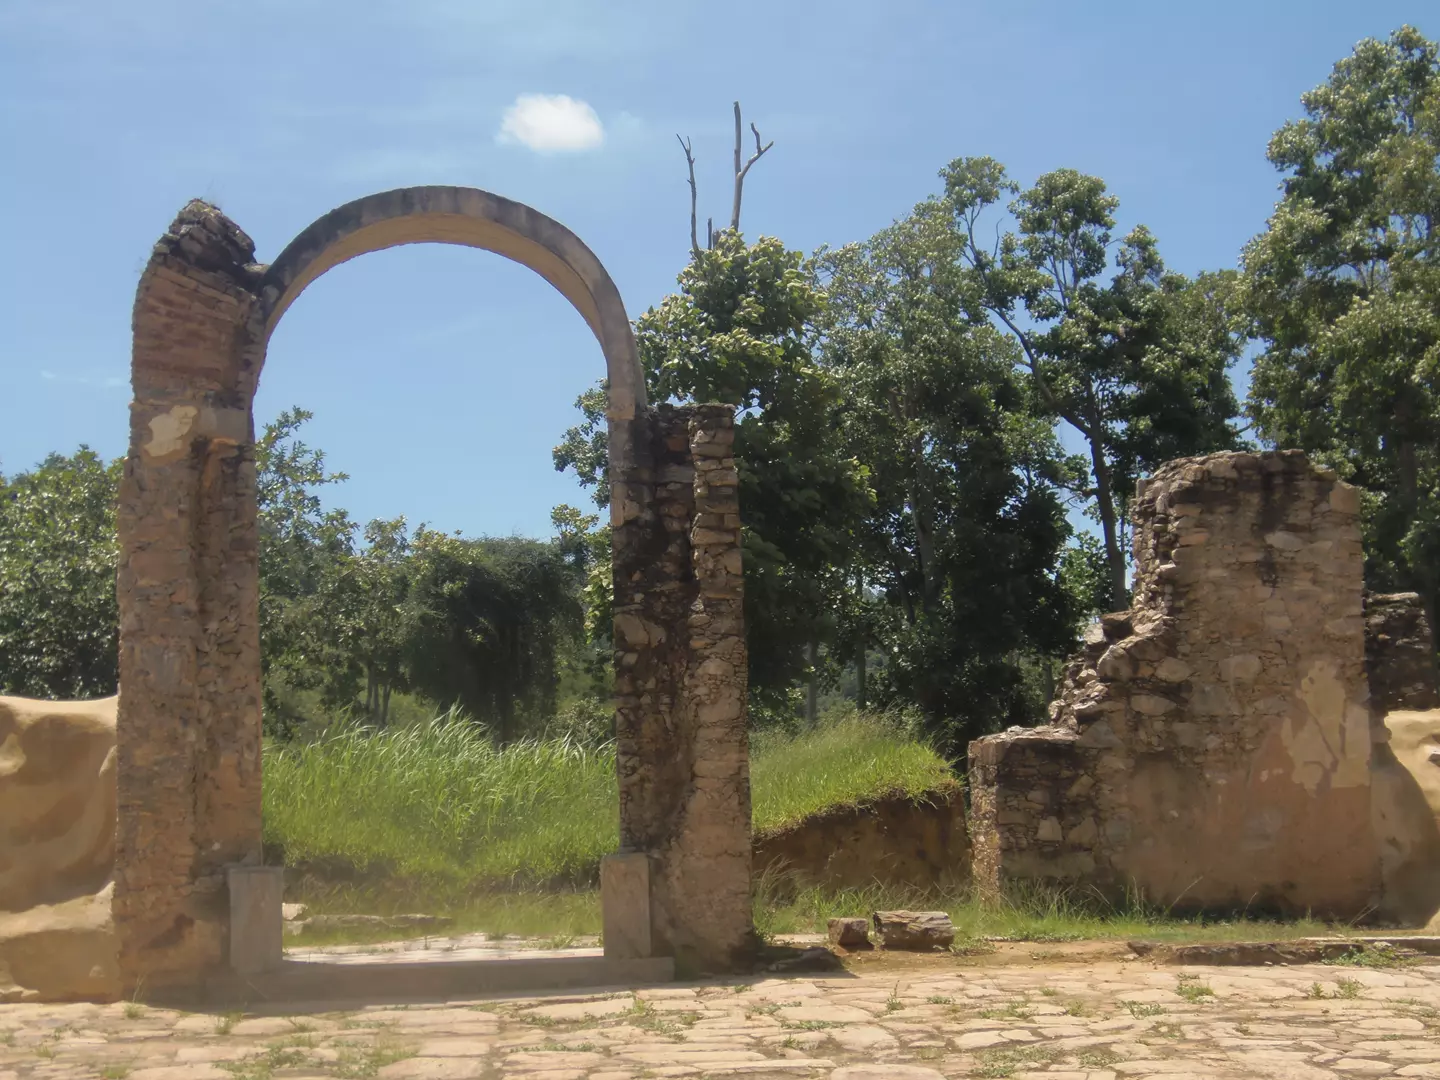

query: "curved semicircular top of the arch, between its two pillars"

left=259, top=186, right=647, bottom=420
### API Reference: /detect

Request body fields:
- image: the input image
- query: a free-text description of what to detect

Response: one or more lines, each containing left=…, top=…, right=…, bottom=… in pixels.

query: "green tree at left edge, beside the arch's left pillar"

left=0, top=446, right=122, bottom=698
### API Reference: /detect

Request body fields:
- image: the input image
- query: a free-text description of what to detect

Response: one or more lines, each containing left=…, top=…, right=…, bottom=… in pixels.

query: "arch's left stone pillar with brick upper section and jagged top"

left=114, top=203, right=261, bottom=986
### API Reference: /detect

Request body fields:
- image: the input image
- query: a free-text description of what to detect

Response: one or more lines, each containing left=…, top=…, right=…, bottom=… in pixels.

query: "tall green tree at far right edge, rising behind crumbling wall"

left=1244, top=26, right=1440, bottom=642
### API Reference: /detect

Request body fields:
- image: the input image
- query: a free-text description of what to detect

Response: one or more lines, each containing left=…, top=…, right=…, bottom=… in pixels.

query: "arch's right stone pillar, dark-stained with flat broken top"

left=612, top=406, right=755, bottom=971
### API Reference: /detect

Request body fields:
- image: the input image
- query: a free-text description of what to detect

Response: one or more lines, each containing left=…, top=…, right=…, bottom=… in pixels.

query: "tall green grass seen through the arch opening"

left=265, top=714, right=619, bottom=884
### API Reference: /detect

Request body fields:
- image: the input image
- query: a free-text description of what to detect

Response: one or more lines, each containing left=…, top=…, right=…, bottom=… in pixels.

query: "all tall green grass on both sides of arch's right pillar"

left=265, top=713, right=953, bottom=888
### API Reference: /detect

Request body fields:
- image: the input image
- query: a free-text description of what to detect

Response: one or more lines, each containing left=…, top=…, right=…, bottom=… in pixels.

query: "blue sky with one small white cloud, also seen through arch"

left=0, top=0, right=1440, bottom=534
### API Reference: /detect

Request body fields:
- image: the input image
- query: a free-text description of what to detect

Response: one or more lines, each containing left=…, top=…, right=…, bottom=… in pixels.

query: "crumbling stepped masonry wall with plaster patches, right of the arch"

left=969, top=451, right=1380, bottom=917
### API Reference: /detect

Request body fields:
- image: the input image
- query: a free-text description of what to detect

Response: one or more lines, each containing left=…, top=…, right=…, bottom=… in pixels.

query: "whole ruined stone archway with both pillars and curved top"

left=114, top=187, right=753, bottom=986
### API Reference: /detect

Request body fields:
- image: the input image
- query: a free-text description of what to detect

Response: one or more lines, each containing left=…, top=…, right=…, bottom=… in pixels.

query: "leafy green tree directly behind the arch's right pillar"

left=554, top=229, right=870, bottom=717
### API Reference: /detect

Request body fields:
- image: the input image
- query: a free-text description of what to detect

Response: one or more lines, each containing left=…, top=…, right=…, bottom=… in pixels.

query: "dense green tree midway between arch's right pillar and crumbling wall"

left=821, top=203, right=1071, bottom=755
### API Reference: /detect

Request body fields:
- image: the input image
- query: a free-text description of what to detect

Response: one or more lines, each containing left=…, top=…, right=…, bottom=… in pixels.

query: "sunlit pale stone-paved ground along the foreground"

left=0, top=960, right=1440, bottom=1080
